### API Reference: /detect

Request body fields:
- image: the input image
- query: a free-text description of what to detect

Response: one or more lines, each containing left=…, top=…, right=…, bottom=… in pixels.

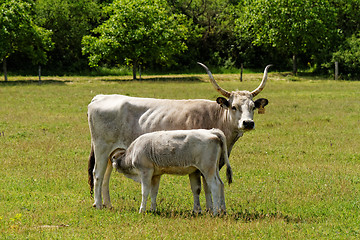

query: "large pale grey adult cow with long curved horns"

left=88, top=63, right=270, bottom=209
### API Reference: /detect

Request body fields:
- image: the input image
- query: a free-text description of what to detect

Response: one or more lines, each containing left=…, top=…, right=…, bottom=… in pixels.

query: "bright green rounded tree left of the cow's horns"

left=82, top=0, right=188, bottom=79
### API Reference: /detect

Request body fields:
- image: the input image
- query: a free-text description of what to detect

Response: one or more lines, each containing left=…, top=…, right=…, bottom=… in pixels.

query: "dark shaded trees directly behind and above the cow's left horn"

left=167, top=0, right=238, bottom=66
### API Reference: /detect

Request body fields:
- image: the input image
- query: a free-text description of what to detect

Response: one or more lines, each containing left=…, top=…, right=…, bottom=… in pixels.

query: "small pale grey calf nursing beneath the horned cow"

left=109, top=129, right=232, bottom=214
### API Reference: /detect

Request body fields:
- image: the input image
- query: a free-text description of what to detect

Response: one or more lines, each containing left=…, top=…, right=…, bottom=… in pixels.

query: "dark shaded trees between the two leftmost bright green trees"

left=34, top=0, right=101, bottom=72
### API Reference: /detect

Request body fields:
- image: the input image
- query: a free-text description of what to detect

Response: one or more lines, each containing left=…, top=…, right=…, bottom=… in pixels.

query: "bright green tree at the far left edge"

left=0, top=0, right=52, bottom=81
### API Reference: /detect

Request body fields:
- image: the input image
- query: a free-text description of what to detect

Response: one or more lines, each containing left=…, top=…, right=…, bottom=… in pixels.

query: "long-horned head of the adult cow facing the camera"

left=199, top=63, right=271, bottom=131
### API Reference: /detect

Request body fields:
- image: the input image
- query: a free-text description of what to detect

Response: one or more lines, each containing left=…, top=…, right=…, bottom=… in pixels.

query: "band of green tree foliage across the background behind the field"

left=0, top=0, right=360, bottom=77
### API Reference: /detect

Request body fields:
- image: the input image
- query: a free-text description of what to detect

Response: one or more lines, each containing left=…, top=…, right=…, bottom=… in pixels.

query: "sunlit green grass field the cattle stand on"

left=0, top=73, right=360, bottom=239
